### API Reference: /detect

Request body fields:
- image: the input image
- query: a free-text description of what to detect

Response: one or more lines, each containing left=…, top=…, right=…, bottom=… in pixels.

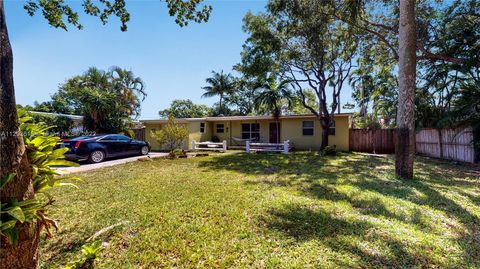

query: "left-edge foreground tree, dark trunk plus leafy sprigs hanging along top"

left=0, top=0, right=211, bottom=269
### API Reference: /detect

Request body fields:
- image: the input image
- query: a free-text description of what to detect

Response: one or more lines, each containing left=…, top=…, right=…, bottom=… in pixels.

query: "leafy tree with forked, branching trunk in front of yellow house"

left=241, top=0, right=357, bottom=149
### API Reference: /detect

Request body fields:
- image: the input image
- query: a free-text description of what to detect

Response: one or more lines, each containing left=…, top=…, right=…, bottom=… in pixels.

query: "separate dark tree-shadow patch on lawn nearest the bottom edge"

left=263, top=205, right=431, bottom=268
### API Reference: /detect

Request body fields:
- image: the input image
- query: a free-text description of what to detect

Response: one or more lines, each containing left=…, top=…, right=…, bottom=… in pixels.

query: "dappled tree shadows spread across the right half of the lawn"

left=200, top=153, right=480, bottom=267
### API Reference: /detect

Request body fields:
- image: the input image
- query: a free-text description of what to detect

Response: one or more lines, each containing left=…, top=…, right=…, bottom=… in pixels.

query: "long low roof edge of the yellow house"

left=140, top=113, right=352, bottom=123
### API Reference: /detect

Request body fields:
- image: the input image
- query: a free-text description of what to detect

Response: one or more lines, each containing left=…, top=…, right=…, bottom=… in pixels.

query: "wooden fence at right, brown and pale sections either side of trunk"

left=349, top=127, right=475, bottom=163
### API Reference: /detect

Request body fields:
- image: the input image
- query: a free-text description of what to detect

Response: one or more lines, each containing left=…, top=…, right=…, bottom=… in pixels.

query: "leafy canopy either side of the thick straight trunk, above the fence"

left=344, top=0, right=480, bottom=128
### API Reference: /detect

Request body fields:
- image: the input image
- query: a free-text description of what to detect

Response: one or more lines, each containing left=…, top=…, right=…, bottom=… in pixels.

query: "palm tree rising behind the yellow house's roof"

left=202, top=70, right=235, bottom=113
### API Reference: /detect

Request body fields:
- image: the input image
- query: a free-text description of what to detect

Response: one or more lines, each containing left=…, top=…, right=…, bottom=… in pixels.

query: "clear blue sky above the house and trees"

left=5, top=0, right=351, bottom=119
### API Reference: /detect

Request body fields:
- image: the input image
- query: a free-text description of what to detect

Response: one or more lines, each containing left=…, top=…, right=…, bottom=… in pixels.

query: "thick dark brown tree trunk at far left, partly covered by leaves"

left=0, top=0, right=39, bottom=269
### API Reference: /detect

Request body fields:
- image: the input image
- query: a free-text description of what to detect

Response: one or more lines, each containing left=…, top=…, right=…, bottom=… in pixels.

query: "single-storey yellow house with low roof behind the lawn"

left=141, top=113, right=351, bottom=151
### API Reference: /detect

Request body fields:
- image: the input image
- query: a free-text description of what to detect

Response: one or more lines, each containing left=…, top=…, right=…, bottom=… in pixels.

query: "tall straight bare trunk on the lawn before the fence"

left=395, top=0, right=417, bottom=179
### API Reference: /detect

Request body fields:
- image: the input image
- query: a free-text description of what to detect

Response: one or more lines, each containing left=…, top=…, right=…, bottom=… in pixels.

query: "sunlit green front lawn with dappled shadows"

left=41, top=153, right=480, bottom=268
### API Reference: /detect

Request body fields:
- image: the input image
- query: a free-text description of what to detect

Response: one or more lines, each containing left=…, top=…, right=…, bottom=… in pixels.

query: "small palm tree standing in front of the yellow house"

left=254, top=79, right=294, bottom=142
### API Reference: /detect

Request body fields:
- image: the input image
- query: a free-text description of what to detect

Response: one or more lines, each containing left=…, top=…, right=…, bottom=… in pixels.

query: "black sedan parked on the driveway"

left=61, top=134, right=150, bottom=163
